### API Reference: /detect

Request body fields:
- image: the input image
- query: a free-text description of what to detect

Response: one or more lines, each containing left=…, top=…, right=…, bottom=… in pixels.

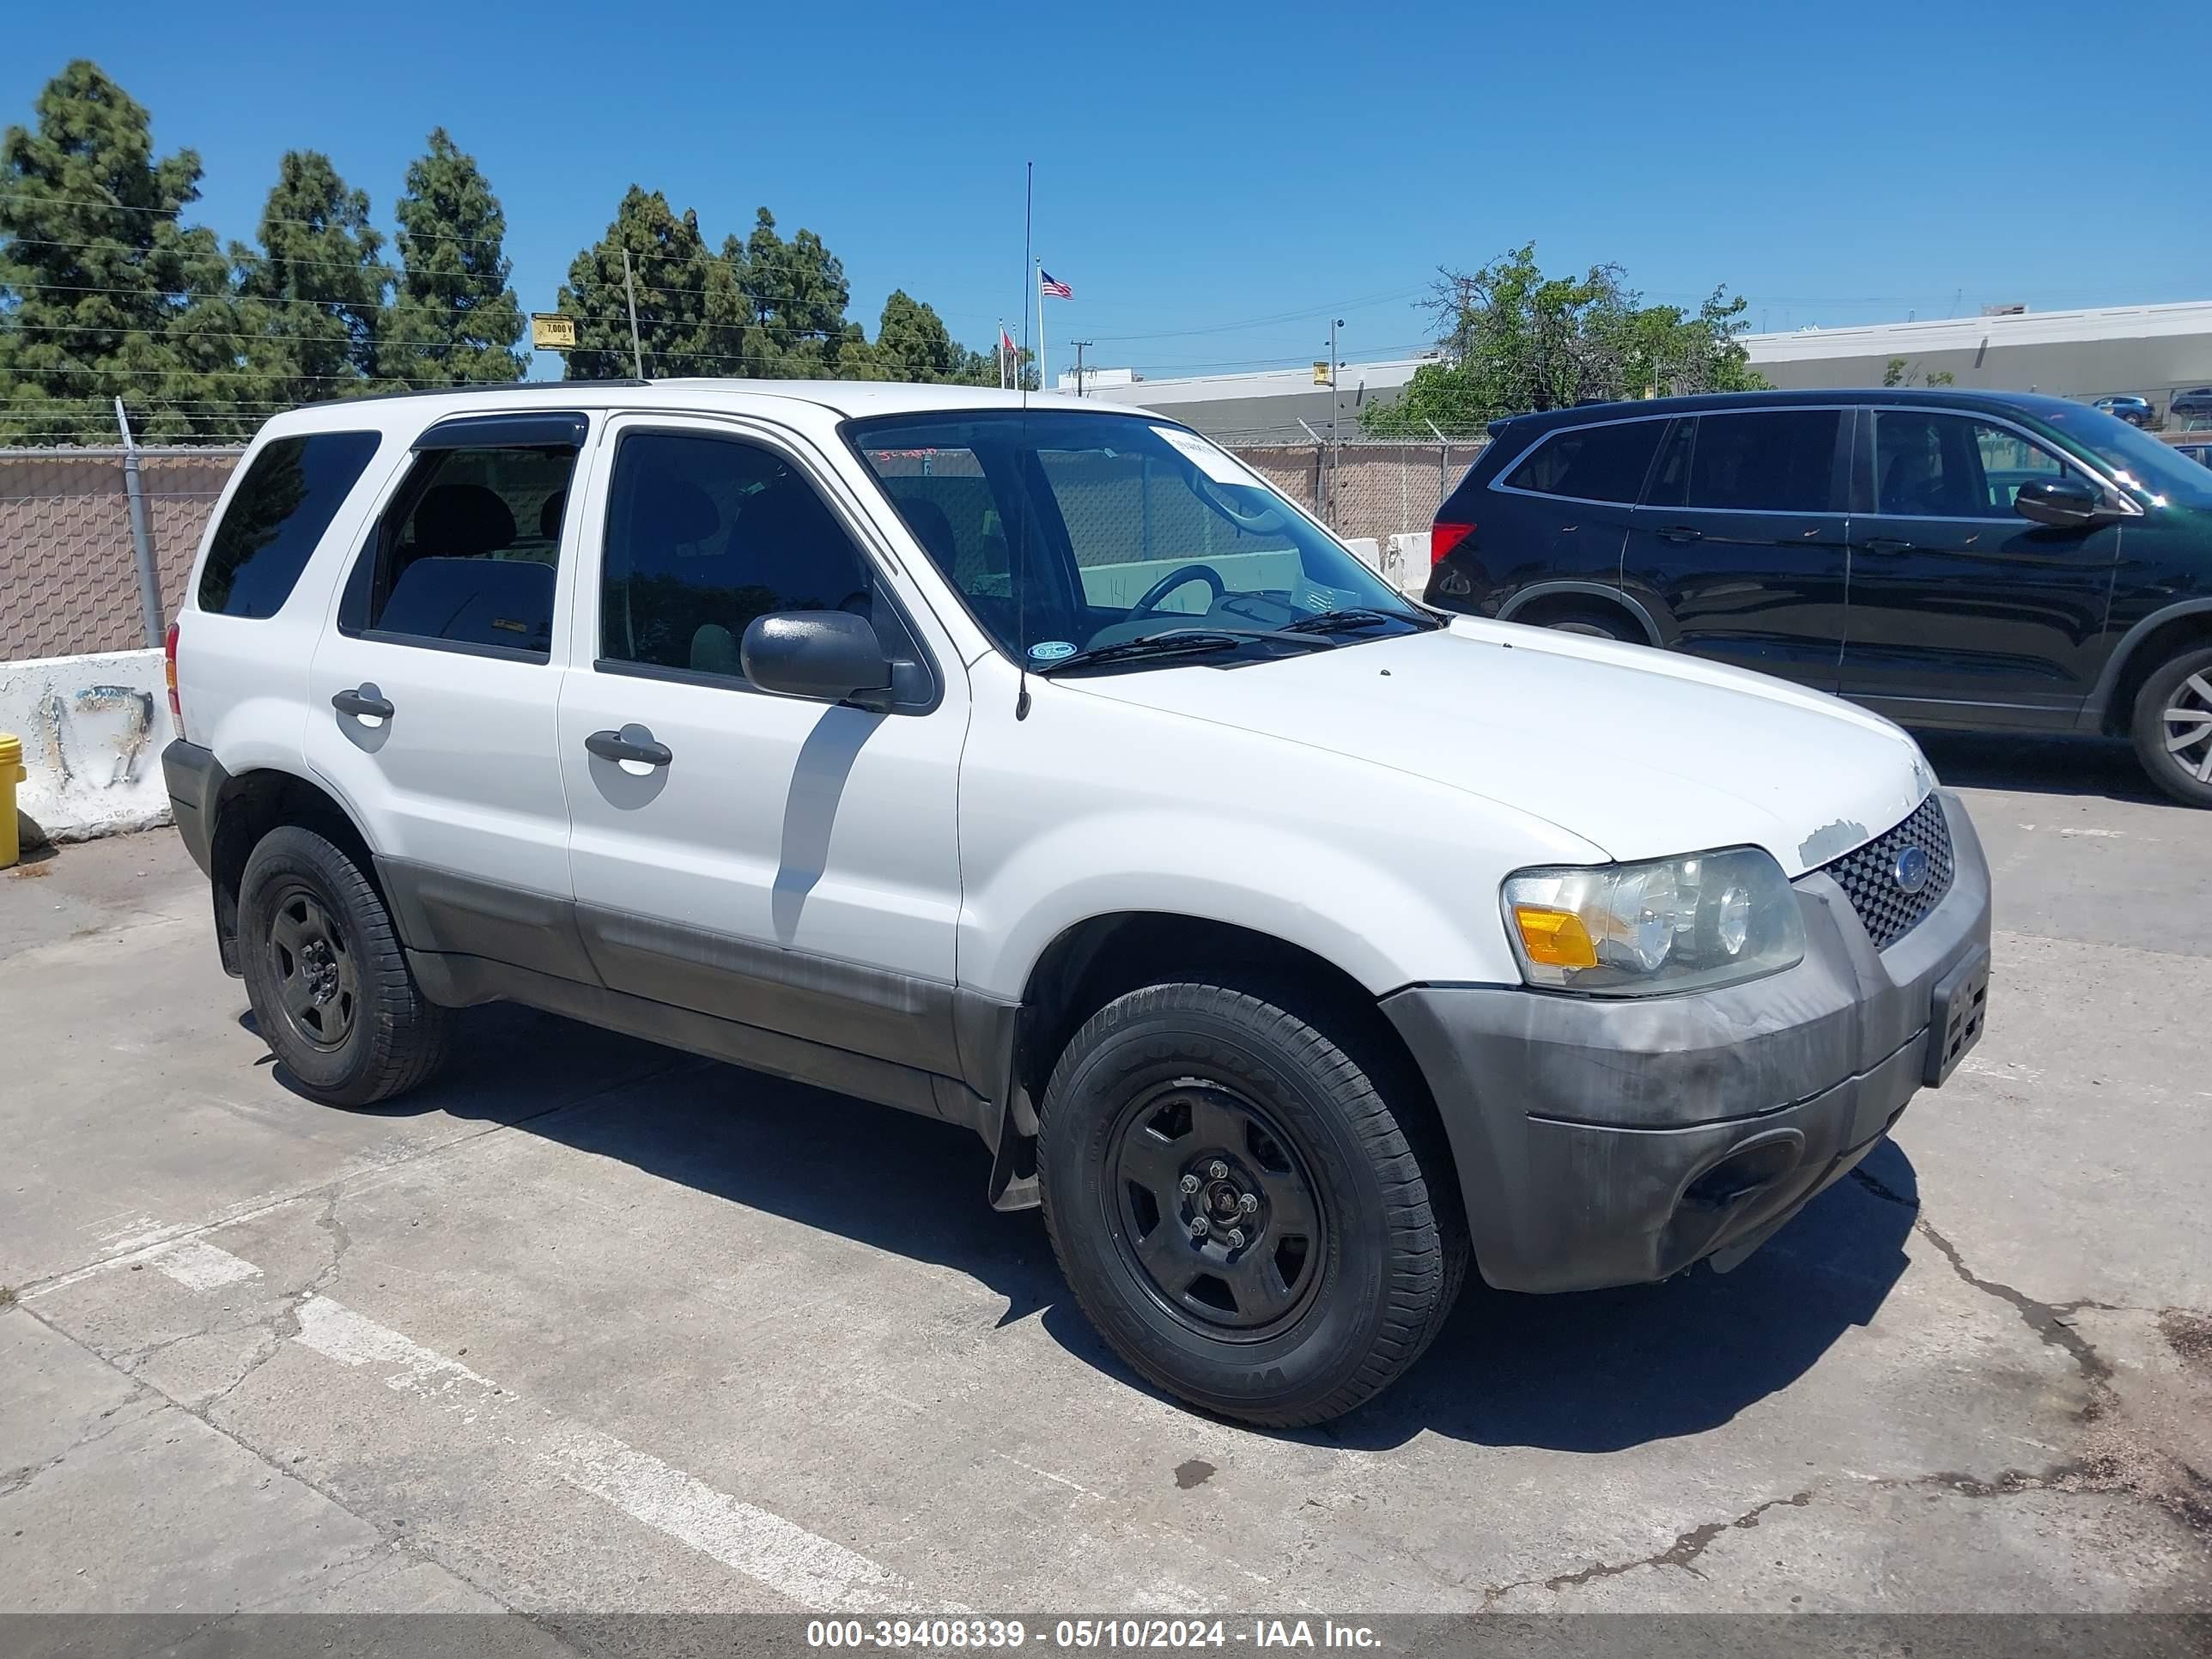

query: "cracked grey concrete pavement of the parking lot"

left=0, top=744, right=2212, bottom=1614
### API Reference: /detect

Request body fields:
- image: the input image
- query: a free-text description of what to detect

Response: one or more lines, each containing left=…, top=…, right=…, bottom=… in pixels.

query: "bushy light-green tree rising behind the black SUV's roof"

left=1360, top=243, right=1765, bottom=434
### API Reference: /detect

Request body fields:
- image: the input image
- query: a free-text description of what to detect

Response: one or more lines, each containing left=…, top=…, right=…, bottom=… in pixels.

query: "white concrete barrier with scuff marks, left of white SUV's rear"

left=0, top=650, right=170, bottom=841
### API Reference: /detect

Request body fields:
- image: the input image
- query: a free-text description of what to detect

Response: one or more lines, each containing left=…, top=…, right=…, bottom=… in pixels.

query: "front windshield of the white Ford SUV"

left=848, top=410, right=1436, bottom=668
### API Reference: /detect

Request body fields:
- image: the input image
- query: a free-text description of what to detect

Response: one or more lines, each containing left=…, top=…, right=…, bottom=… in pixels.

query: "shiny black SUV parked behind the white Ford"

left=1427, top=389, right=2212, bottom=807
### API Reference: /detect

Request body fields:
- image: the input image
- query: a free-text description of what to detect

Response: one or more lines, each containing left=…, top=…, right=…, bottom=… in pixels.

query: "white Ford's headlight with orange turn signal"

left=1504, top=848, right=1805, bottom=995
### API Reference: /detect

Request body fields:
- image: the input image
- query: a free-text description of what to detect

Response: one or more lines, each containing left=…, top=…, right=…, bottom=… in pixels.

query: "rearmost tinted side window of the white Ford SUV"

left=199, top=431, right=378, bottom=617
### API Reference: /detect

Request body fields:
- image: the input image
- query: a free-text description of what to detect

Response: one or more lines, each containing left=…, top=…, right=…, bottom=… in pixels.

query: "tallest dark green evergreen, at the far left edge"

left=0, top=58, right=237, bottom=442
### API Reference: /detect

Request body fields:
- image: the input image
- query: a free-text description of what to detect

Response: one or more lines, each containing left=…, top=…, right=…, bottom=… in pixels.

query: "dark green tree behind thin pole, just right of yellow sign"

left=560, top=184, right=752, bottom=380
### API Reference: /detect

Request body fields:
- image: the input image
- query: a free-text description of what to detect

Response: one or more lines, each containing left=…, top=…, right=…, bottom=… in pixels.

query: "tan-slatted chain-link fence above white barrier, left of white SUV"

left=0, top=447, right=243, bottom=661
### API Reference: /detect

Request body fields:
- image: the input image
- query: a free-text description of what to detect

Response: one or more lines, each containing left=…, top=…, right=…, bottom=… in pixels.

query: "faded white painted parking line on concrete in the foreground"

left=174, top=1241, right=942, bottom=1613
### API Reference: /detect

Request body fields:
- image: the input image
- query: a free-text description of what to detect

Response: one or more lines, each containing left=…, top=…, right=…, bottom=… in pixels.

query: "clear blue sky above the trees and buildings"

left=0, top=0, right=2212, bottom=374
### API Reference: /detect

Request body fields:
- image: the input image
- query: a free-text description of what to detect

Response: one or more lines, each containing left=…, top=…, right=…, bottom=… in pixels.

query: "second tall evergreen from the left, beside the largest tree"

left=230, top=150, right=392, bottom=404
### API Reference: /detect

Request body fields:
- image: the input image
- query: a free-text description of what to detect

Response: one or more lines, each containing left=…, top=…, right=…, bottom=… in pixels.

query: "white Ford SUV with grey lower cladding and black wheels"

left=164, top=380, right=1989, bottom=1425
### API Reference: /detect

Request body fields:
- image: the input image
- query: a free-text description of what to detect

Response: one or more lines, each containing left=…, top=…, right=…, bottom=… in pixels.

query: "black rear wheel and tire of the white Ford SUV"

left=239, top=825, right=452, bottom=1106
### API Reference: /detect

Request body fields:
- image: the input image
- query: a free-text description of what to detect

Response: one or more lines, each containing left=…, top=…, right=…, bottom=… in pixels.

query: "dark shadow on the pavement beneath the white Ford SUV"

left=263, top=1006, right=1917, bottom=1451
